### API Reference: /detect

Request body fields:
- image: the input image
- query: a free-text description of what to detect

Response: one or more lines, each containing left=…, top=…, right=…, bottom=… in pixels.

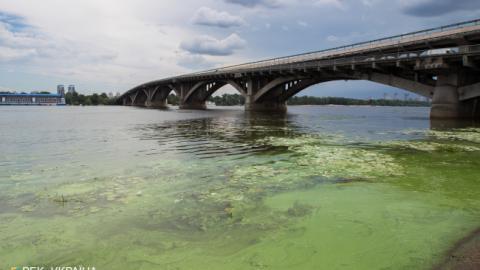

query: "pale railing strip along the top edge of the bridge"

left=182, top=19, right=480, bottom=77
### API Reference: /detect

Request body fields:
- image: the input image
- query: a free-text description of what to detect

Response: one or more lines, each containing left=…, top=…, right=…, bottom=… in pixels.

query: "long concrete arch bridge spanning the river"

left=122, top=19, right=480, bottom=118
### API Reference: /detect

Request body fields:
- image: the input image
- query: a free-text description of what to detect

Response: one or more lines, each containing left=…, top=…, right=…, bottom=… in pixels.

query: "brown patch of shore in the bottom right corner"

left=433, top=228, right=480, bottom=270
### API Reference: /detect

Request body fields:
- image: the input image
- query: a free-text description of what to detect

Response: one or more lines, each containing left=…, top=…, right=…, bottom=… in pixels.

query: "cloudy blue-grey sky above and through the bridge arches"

left=0, top=0, right=480, bottom=98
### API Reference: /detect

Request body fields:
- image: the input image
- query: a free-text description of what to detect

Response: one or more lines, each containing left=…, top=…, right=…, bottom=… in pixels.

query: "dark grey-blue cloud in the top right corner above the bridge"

left=403, top=0, right=480, bottom=17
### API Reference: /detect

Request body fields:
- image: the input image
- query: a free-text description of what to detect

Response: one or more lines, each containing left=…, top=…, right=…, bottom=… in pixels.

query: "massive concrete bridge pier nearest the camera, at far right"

left=430, top=71, right=473, bottom=119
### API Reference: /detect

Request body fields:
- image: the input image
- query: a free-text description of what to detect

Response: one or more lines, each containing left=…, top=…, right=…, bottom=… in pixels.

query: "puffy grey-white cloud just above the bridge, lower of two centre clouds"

left=180, top=33, right=247, bottom=56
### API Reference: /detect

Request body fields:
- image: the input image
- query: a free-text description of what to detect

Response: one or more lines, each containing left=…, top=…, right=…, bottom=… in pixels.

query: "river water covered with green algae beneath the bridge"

left=0, top=107, right=480, bottom=269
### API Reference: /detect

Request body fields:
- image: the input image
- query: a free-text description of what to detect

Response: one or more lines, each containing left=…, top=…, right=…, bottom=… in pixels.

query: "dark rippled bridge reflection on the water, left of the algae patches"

left=131, top=112, right=299, bottom=159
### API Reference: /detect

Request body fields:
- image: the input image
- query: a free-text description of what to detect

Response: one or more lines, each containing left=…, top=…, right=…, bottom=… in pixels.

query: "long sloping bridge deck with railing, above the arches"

left=127, top=19, right=480, bottom=96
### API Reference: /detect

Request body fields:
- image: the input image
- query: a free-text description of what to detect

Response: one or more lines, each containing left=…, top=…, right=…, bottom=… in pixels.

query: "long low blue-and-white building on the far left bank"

left=0, top=93, right=65, bottom=106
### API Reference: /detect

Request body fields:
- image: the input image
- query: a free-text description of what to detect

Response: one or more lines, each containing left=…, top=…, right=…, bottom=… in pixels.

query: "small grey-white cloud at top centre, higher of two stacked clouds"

left=192, top=7, right=245, bottom=28
